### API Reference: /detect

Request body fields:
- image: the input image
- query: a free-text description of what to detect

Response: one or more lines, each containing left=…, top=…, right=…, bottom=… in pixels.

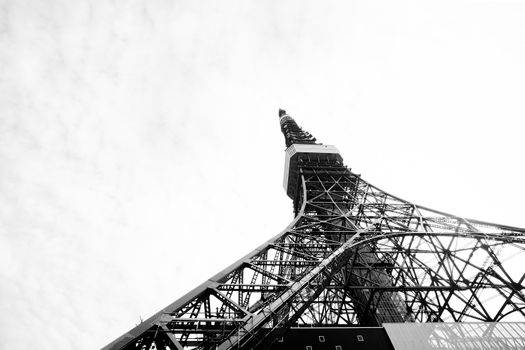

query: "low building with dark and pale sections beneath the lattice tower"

left=271, top=322, right=525, bottom=350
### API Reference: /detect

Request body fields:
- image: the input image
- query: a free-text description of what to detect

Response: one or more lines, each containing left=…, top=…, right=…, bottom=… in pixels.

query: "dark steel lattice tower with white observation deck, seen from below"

left=106, top=110, right=525, bottom=349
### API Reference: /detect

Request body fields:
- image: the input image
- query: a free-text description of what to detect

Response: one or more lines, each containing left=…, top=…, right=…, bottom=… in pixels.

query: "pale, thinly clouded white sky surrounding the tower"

left=0, top=0, right=525, bottom=349
